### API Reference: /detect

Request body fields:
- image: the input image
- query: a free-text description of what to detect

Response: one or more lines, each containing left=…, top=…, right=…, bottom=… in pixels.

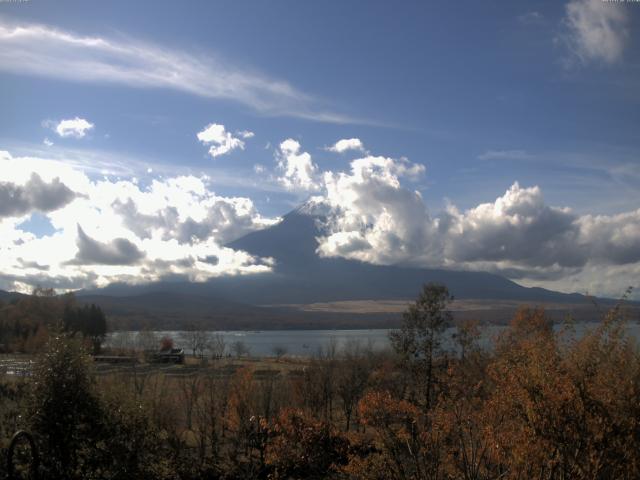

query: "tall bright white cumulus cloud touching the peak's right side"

left=318, top=157, right=432, bottom=264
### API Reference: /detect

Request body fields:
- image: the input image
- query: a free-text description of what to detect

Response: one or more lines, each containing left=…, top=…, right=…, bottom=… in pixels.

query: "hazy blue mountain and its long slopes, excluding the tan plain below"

left=86, top=205, right=584, bottom=307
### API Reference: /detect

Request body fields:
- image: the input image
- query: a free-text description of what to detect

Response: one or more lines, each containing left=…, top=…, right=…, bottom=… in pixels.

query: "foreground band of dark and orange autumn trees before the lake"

left=0, top=285, right=640, bottom=480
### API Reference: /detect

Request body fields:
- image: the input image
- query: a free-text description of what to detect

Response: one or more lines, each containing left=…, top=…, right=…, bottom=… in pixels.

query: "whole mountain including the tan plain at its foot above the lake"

left=70, top=204, right=616, bottom=329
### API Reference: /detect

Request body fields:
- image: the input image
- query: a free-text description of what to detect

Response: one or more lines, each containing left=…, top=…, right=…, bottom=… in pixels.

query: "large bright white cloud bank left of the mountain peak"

left=0, top=152, right=277, bottom=289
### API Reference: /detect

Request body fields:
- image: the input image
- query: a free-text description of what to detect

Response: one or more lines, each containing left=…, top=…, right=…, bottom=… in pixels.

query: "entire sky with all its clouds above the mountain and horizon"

left=0, top=0, right=640, bottom=298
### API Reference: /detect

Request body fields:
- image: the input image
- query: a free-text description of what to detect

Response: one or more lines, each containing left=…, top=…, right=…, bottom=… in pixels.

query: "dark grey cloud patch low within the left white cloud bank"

left=70, top=225, right=144, bottom=265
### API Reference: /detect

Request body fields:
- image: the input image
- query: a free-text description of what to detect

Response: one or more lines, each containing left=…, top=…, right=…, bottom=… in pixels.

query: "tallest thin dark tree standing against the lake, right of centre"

left=389, top=283, right=453, bottom=410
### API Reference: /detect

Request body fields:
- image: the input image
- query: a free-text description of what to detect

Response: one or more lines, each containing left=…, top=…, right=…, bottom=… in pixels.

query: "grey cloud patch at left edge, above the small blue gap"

left=0, top=172, right=76, bottom=219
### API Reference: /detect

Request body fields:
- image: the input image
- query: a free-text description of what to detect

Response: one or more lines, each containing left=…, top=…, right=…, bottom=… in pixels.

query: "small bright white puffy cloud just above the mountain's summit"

left=276, top=138, right=321, bottom=191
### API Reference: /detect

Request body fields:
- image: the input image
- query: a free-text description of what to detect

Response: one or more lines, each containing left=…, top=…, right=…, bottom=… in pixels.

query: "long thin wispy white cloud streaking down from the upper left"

left=0, top=18, right=360, bottom=123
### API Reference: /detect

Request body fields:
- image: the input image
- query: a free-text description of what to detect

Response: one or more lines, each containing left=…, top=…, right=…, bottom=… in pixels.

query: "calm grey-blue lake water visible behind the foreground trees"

left=105, top=323, right=640, bottom=357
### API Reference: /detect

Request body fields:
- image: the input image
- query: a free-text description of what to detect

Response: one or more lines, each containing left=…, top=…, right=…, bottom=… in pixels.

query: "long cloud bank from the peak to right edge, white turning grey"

left=315, top=169, right=640, bottom=294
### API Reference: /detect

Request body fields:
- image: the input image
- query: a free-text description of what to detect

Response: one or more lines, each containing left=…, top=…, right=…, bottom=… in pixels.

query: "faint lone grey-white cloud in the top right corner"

left=564, top=0, right=629, bottom=64
